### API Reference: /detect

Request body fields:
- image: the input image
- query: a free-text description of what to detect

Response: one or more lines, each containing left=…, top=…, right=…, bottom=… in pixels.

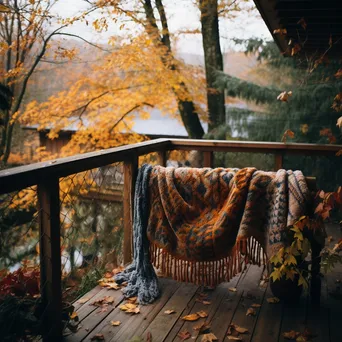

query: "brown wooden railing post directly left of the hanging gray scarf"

left=123, top=155, right=138, bottom=264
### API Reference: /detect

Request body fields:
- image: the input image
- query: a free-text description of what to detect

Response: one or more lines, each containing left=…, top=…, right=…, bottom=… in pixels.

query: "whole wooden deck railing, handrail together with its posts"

left=0, top=139, right=342, bottom=340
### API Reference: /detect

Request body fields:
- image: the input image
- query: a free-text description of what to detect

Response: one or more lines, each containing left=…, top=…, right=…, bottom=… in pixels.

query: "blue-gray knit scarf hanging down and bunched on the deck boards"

left=114, top=164, right=160, bottom=304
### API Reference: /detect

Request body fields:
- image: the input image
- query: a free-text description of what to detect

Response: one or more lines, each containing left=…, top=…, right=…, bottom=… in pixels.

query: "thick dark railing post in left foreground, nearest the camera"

left=37, top=178, right=63, bottom=341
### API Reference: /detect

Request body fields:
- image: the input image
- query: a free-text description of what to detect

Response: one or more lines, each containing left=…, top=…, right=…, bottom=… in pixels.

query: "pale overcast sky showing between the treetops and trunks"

left=55, top=0, right=271, bottom=54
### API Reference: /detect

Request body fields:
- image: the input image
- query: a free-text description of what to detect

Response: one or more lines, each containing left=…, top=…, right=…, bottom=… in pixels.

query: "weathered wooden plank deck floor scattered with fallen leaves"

left=65, top=226, right=342, bottom=342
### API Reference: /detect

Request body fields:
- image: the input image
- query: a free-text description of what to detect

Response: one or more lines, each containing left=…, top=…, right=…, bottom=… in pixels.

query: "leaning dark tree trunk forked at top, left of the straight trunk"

left=144, top=0, right=204, bottom=139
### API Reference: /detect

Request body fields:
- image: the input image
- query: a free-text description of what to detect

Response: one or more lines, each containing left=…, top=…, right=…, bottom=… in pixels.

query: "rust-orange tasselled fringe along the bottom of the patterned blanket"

left=150, top=237, right=267, bottom=286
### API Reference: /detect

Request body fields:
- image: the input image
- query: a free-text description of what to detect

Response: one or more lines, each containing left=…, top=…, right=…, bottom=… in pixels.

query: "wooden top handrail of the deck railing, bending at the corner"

left=0, top=139, right=342, bottom=194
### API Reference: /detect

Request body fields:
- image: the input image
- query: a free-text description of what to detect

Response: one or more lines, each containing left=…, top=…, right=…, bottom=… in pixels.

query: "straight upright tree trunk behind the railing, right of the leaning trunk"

left=199, top=0, right=226, bottom=130
